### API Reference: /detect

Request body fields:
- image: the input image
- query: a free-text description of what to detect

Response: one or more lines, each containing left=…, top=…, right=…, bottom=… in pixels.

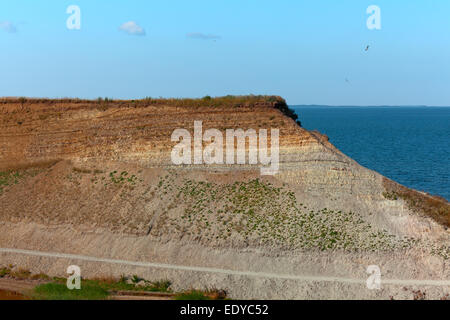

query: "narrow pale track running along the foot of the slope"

left=0, top=248, right=450, bottom=287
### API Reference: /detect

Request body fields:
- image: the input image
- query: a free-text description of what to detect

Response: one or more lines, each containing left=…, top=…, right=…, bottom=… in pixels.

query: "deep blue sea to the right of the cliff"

left=291, top=106, right=450, bottom=200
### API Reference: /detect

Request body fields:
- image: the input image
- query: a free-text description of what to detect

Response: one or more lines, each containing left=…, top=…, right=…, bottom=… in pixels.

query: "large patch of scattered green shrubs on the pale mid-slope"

left=158, top=175, right=426, bottom=252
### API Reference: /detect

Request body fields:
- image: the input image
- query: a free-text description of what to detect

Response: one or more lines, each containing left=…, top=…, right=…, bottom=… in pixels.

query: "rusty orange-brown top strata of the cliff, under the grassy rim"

left=0, top=98, right=326, bottom=167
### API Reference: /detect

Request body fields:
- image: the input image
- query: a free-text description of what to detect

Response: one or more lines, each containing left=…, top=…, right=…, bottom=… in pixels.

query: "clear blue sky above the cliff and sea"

left=0, top=0, right=450, bottom=106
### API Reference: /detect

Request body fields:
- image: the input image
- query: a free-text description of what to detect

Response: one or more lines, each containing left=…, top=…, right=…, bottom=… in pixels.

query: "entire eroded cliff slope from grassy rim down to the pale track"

left=0, top=97, right=450, bottom=298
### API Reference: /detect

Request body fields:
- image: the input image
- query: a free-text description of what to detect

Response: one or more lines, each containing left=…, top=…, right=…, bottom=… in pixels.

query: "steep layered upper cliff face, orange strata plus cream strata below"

left=0, top=98, right=379, bottom=200
